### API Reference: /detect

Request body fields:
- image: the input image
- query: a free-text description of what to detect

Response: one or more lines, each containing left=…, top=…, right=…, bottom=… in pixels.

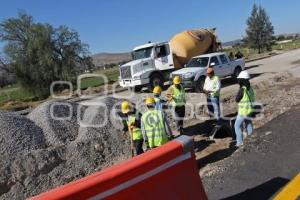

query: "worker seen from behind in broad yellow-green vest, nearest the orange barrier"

left=141, top=97, right=171, bottom=149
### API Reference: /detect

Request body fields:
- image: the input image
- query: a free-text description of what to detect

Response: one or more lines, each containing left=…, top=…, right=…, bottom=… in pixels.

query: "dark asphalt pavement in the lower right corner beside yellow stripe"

left=203, top=105, right=300, bottom=200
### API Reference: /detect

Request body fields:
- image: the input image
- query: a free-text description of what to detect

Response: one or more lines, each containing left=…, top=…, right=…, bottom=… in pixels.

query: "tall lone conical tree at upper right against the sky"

left=245, top=4, right=274, bottom=53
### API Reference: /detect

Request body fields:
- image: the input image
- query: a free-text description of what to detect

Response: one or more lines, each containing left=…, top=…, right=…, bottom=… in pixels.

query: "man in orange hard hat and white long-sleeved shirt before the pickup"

left=203, top=67, right=221, bottom=122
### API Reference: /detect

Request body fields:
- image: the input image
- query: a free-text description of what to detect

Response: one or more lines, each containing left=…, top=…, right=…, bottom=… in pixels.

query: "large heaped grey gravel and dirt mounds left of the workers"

left=0, top=98, right=131, bottom=199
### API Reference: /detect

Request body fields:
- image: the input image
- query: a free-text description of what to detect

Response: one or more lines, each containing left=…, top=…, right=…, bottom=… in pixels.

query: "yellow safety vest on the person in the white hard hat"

left=238, top=86, right=255, bottom=116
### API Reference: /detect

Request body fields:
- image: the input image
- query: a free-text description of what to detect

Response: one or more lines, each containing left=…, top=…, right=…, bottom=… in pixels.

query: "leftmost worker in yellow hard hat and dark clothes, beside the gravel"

left=121, top=101, right=144, bottom=155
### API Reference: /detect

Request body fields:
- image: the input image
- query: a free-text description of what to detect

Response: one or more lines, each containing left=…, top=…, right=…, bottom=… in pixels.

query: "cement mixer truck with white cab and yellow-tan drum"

left=119, top=29, right=218, bottom=91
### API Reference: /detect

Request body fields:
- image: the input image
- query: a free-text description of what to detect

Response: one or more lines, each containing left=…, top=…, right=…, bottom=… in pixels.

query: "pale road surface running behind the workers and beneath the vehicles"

left=85, top=49, right=300, bottom=104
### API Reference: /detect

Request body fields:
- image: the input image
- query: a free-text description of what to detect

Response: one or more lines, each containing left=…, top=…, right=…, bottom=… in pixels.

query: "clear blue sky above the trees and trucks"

left=0, top=0, right=300, bottom=54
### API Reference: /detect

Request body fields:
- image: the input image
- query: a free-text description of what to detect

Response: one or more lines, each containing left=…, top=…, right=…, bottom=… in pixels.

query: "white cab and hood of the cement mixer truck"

left=119, top=42, right=174, bottom=90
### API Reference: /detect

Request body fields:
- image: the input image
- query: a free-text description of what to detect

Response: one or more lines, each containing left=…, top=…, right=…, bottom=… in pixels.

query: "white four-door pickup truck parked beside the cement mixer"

left=170, top=52, right=245, bottom=92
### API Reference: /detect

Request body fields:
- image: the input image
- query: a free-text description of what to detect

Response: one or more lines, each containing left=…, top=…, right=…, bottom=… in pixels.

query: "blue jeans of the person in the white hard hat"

left=234, top=115, right=253, bottom=145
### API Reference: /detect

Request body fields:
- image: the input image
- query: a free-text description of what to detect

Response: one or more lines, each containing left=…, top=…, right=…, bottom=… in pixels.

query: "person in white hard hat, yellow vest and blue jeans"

left=234, top=70, right=255, bottom=147
